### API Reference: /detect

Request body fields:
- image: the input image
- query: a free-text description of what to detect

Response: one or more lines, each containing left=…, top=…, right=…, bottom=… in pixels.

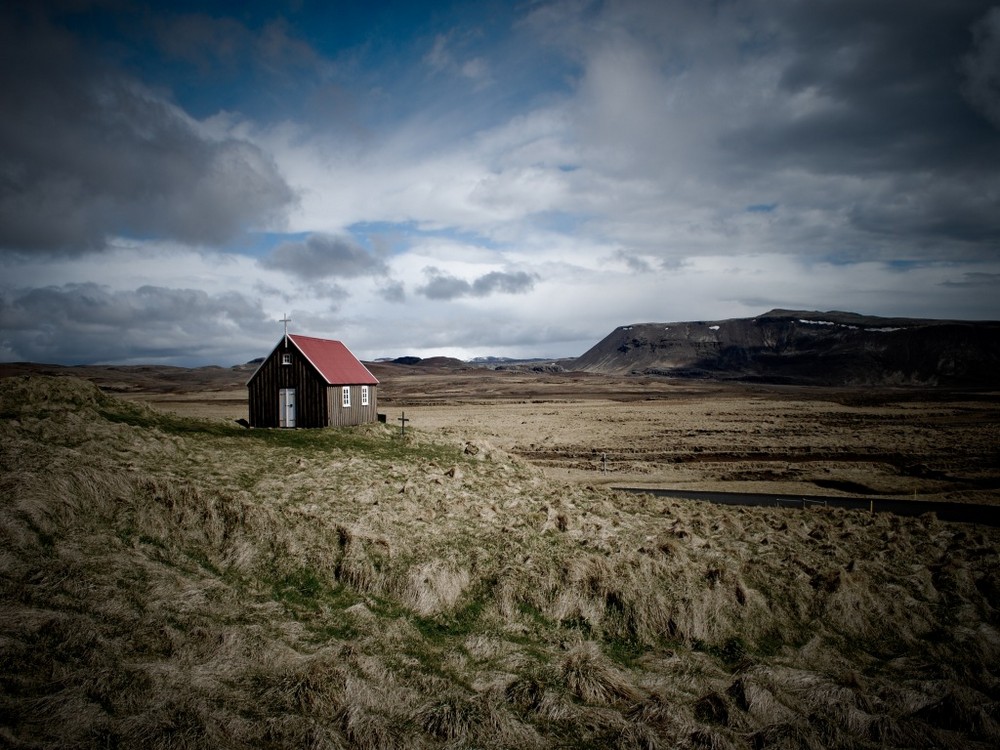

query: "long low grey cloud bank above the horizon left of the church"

left=0, top=283, right=274, bottom=364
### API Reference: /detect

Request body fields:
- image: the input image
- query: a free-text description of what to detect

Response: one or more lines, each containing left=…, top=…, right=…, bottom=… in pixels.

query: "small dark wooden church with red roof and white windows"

left=247, top=333, right=378, bottom=427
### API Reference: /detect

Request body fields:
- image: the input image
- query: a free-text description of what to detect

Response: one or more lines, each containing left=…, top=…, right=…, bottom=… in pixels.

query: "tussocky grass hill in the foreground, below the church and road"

left=0, top=377, right=1000, bottom=748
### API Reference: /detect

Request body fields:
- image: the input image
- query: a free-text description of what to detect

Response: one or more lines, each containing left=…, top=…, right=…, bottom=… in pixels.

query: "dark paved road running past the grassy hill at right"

left=613, top=487, right=1000, bottom=526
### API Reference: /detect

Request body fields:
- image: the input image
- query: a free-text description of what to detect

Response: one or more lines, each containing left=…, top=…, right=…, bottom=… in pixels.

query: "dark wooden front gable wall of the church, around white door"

left=247, top=339, right=326, bottom=427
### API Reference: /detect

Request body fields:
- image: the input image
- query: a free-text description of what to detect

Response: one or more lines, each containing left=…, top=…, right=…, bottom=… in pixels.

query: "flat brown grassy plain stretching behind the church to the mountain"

left=128, top=365, right=1000, bottom=504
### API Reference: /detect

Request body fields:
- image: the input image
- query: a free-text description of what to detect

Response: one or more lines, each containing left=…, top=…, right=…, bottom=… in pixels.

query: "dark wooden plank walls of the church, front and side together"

left=247, top=340, right=378, bottom=427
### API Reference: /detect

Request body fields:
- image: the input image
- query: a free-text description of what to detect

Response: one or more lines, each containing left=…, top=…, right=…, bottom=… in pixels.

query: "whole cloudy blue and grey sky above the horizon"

left=0, top=0, right=1000, bottom=366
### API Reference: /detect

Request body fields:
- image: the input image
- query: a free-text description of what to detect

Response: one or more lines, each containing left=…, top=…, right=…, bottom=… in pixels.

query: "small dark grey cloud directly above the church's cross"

left=260, top=234, right=387, bottom=281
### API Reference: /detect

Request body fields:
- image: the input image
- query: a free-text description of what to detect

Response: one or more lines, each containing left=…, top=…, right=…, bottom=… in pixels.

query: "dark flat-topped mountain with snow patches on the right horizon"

left=574, top=310, right=1000, bottom=387
